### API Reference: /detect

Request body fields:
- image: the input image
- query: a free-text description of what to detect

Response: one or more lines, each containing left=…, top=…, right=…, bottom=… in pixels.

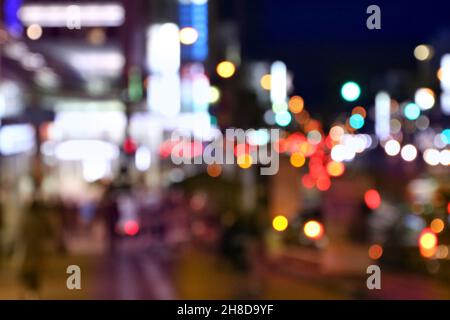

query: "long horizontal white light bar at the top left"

left=18, top=3, right=125, bottom=27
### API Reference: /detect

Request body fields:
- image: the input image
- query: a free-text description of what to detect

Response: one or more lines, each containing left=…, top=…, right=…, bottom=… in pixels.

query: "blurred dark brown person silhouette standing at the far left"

left=18, top=182, right=53, bottom=299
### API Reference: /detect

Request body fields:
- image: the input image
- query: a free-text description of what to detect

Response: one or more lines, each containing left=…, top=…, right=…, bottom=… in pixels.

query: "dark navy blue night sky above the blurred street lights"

left=230, top=0, right=450, bottom=119
